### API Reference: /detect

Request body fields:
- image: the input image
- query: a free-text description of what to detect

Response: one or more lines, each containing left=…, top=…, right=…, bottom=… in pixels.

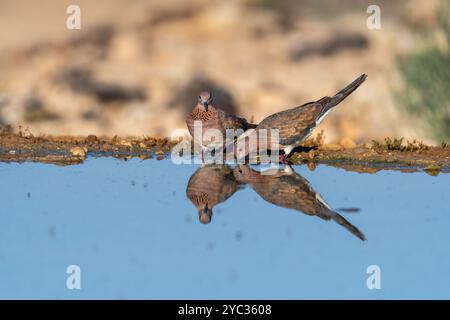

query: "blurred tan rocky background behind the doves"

left=0, top=0, right=450, bottom=143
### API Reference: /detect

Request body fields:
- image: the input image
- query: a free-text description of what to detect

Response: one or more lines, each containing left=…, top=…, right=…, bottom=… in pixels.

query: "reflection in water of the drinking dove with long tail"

left=233, top=165, right=366, bottom=240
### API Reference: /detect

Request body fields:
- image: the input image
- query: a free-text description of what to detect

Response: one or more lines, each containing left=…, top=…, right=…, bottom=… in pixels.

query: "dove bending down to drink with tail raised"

left=237, top=74, right=367, bottom=162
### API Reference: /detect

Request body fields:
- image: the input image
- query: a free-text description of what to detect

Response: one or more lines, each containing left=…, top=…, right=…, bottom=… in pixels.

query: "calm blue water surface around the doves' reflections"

left=0, top=158, right=450, bottom=299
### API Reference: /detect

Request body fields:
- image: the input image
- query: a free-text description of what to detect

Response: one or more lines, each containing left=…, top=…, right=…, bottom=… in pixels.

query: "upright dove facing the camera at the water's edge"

left=186, top=91, right=256, bottom=147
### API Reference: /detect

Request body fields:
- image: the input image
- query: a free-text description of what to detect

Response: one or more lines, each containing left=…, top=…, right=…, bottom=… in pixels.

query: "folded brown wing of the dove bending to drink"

left=258, top=102, right=324, bottom=145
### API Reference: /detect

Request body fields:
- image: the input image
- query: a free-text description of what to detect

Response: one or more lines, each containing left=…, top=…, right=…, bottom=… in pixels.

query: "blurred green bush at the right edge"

left=398, top=1, right=450, bottom=141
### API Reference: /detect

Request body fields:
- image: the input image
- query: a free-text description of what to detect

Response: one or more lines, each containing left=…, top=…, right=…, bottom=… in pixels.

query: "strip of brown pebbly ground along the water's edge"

left=0, top=132, right=450, bottom=175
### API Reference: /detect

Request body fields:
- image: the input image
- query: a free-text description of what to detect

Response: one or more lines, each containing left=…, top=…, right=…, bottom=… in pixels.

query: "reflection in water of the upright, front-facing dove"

left=186, top=164, right=238, bottom=224
